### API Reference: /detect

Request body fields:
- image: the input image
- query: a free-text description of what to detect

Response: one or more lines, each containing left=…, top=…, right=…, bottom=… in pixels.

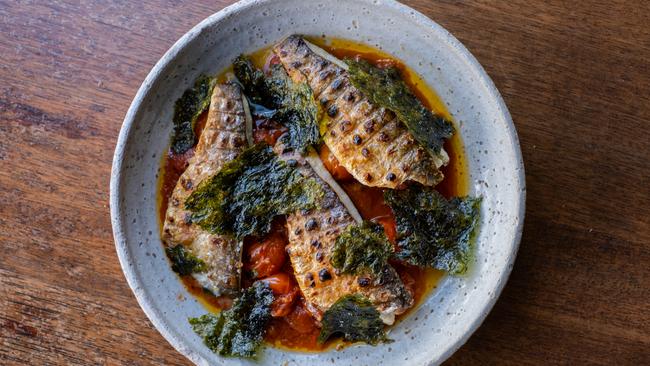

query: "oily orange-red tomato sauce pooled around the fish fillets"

left=159, top=39, right=468, bottom=352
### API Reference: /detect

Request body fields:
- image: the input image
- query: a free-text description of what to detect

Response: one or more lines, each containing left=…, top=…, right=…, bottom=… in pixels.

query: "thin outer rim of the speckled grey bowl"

left=110, top=0, right=526, bottom=365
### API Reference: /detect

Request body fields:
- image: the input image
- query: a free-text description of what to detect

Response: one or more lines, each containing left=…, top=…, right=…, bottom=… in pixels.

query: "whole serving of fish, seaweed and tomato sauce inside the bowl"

left=159, top=35, right=481, bottom=358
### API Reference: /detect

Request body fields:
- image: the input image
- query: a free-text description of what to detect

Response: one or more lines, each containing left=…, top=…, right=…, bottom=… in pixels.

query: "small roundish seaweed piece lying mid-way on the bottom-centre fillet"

left=331, top=221, right=393, bottom=275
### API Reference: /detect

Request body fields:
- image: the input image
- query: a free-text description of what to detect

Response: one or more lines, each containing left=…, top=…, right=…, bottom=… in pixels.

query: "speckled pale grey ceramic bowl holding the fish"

left=111, top=0, right=525, bottom=366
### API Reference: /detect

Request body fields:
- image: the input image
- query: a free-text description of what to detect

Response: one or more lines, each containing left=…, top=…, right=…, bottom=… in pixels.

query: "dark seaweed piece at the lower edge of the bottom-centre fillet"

left=318, top=294, right=391, bottom=345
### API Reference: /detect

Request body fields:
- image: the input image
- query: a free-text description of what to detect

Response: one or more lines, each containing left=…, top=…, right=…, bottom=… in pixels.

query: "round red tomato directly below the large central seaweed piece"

left=246, top=232, right=287, bottom=278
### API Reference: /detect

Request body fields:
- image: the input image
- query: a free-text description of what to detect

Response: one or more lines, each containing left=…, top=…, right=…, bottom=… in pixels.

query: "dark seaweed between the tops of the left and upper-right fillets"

left=233, top=56, right=320, bottom=152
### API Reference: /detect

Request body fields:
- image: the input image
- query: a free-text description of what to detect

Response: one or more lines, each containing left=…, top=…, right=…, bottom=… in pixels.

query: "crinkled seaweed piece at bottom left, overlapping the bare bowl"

left=189, top=282, right=273, bottom=358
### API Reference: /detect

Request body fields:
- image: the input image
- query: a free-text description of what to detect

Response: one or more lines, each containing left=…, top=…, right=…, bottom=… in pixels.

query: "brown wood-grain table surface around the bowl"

left=0, top=0, right=650, bottom=365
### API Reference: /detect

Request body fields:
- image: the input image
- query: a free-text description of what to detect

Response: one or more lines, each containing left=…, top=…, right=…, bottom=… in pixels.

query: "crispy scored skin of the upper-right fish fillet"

left=273, top=35, right=447, bottom=188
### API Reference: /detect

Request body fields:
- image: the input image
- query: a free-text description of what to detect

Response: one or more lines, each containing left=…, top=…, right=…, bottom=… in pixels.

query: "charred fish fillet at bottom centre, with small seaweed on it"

left=274, top=143, right=413, bottom=324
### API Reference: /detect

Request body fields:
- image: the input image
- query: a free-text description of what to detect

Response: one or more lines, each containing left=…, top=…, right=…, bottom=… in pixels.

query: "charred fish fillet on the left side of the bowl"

left=162, top=84, right=246, bottom=296
